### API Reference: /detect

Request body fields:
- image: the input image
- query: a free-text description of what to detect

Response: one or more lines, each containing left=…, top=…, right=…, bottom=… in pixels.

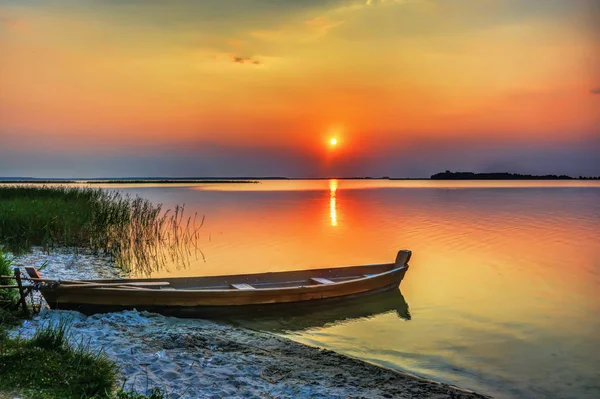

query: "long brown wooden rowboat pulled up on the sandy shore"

left=26, top=250, right=411, bottom=317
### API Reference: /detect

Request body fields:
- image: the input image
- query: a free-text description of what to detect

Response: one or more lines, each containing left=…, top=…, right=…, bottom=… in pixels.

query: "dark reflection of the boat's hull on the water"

left=227, top=289, right=411, bottom=333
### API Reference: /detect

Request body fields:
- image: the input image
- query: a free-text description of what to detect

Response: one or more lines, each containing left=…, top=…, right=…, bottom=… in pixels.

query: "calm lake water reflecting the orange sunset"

left=96, top=180, right=600, bottom=398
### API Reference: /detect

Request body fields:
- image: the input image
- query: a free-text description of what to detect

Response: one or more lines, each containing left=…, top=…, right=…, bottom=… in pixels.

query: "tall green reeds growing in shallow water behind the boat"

left=0, top=186, right=204, bottom=273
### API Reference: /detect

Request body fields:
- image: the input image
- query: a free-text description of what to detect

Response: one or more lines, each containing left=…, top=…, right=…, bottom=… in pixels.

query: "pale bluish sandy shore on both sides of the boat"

left=13, top=249, right=489, bottom=399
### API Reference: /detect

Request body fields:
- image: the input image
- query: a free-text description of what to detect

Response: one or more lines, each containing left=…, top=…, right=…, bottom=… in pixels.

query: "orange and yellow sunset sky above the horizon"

left=0, top=0, right=600, bottom=177
